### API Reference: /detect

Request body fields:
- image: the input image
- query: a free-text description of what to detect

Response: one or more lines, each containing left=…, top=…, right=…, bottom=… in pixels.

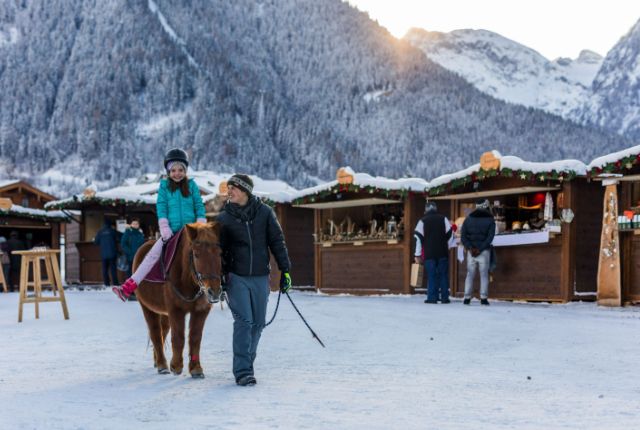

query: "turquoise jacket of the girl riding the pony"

left=156, top=179, right=205, bottom=233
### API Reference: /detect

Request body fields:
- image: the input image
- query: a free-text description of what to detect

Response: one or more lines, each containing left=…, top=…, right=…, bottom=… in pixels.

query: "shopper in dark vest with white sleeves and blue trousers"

left=414, top=202, right=452, bottom=303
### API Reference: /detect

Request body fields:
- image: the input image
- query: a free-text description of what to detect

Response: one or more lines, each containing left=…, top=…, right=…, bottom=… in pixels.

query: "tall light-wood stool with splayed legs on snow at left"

left=13, top=249, right=69, bottom=322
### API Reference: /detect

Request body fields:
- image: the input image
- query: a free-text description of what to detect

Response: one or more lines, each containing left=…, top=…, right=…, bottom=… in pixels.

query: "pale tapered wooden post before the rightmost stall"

left=598, top=180, right=622, bottom=306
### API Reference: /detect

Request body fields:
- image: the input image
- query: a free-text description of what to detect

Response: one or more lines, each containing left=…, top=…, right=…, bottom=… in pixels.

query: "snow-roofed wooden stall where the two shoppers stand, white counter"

left=429, top=151, right=602, bottom=302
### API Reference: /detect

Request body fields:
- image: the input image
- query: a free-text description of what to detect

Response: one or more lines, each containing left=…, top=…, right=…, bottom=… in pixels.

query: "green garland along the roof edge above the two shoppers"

left=428, top=168, right=578, bottom=197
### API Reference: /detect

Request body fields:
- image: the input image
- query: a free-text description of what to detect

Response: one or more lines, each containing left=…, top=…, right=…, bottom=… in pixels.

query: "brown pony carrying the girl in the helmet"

left=133, top=222, right=222, bottom=378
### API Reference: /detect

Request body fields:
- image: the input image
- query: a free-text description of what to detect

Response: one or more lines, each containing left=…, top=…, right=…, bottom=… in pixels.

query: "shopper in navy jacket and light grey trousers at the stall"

left=460, top=199, right=496, bottom=305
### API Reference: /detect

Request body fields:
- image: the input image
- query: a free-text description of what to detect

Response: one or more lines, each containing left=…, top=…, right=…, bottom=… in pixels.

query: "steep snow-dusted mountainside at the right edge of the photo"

left=576, top=21, right=640, bottom=139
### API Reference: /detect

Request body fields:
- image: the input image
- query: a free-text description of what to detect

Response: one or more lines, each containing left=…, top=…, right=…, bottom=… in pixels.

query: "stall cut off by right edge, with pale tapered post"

left=588, top=145, right=640, bottom=306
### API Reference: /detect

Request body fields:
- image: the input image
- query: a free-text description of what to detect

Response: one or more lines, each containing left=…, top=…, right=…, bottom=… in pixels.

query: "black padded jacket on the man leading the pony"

left=217, top=196, right=291, bottom=276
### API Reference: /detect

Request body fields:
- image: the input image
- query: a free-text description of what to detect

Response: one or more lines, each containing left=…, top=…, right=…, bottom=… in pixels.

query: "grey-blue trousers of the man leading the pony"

left=227, top=273, right=269, bottom=381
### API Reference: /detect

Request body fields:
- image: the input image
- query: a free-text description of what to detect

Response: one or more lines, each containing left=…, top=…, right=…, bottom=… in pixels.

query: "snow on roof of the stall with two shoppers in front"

left=430, top=151, right=587, bottom=188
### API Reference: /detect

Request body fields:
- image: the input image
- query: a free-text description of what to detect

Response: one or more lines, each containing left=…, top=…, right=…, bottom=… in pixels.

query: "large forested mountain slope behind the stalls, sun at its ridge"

left=0, top=0, right=631, bottom=197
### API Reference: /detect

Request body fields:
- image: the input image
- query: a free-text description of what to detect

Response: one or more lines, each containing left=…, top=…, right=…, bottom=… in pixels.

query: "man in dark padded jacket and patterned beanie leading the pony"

left=217, top=174, right=291, bottom=386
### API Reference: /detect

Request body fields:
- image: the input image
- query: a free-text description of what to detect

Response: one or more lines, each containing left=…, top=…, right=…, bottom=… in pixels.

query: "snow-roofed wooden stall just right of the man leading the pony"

left=292, top=168, right=428, bottom=294
